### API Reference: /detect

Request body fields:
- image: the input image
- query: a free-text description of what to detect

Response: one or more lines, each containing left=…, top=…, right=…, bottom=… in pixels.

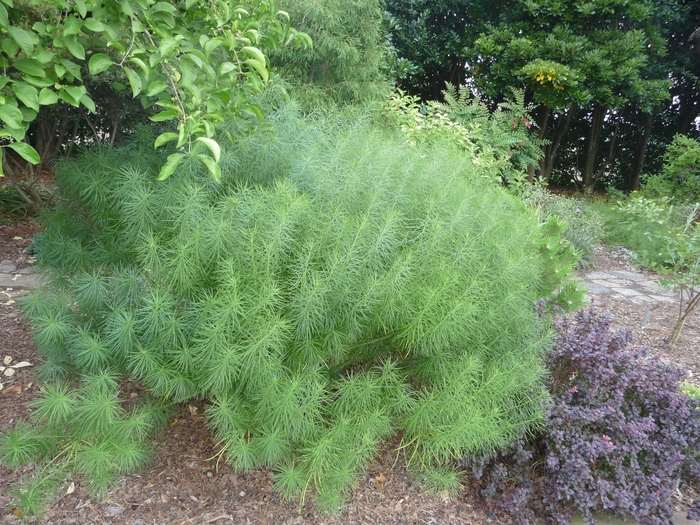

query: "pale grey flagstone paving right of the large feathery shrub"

left=583, top=270, right=678, bottom=306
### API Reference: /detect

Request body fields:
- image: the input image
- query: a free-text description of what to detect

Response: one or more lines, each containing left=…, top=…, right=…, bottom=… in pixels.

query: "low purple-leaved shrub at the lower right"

left=470, top=308, right=700, bottom=525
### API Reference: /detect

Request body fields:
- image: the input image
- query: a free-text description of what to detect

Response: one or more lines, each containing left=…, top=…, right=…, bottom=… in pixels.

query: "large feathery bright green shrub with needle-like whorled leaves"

left=0, top=109, right=577, bottom=511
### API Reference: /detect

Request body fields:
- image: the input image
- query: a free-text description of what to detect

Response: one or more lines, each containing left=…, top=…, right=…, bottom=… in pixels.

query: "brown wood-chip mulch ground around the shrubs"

left=0, top=220, right=700, bottom=525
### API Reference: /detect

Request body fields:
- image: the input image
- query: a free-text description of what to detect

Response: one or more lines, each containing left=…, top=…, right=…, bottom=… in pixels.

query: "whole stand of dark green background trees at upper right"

left=387, top=0, right=700, bottom=189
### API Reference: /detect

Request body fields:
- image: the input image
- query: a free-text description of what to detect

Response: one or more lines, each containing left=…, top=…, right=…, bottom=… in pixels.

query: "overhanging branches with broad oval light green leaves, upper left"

left=0, top=0, right=311, bottom=183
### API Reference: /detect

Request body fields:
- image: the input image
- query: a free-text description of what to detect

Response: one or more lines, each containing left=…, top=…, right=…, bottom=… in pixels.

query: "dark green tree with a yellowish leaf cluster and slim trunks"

left=469, top=0, right=671, bottom=190
